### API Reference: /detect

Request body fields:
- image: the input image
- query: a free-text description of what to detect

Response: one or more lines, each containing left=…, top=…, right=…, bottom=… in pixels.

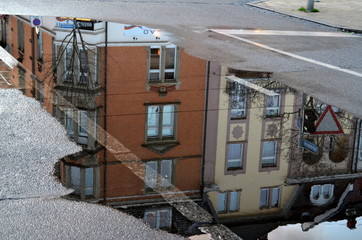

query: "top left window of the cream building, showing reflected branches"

left=230, top=83, right=246, bottom=119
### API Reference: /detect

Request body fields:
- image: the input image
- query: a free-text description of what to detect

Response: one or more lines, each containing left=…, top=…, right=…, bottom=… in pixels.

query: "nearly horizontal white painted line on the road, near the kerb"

left=211, top=29, right=360, bottom=38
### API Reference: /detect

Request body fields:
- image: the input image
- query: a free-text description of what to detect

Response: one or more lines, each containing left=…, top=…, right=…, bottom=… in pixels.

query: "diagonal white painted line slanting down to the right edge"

left=209, top=29, right=362, bottom=77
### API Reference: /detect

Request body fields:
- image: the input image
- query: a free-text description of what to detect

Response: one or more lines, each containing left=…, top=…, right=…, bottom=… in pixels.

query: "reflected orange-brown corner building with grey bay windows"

left=1, top=16, right=206, bottom=232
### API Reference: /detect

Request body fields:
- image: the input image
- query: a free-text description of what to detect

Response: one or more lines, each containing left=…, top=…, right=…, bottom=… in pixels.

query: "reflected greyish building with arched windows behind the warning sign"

left=288, top=97, right=356, bottom=182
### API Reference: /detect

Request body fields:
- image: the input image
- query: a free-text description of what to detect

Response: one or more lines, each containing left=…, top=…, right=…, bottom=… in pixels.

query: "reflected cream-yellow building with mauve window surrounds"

left=205, top=65, right=296, bottom=225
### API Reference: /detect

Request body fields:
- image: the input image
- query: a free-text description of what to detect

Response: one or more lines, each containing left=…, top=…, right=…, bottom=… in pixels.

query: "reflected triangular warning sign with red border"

left=313, top=105, right=343, bottom=134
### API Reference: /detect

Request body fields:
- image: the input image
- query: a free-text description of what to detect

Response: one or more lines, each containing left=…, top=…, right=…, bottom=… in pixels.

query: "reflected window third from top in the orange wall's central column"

left=145, top=160, right=173, bottom=189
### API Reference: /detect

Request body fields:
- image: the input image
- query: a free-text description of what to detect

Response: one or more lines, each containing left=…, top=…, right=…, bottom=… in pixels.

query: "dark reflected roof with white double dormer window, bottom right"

left=229, top=179, right=362, bottom=240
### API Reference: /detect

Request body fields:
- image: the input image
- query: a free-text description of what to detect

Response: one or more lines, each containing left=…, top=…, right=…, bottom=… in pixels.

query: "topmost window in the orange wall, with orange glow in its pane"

left=148, top=46, right=177, bottom=83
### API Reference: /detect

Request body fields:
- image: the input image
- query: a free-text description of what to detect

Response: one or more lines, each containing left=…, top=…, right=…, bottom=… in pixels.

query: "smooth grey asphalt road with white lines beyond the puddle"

left=0, top=0, right=362, bottom=117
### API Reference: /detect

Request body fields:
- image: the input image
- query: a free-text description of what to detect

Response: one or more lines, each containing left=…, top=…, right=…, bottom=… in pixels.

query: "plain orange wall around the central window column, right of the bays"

left=102, top=46, right=206, bottom=200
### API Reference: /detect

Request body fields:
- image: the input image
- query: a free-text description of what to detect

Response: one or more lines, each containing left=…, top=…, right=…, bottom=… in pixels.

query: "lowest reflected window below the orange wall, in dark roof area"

left=143, top=208, right=172, bottom=229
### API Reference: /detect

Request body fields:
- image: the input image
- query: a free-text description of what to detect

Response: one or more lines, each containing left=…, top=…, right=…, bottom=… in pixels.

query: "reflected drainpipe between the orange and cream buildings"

left=200, top=61, right=210, bottom=201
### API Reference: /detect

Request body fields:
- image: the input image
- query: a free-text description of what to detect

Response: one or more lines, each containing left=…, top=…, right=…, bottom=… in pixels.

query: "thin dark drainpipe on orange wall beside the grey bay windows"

left=103, top=22, right=108, bottom=204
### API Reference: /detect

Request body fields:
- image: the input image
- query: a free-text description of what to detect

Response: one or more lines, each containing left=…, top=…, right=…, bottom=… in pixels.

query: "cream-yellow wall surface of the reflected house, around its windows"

left=205, top=67, right=295, bottom=218
